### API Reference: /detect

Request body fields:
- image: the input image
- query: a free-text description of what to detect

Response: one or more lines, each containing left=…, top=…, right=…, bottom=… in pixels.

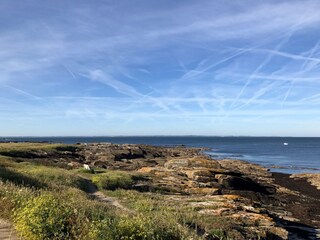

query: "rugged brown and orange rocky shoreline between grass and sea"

left=3, top=143, right=320, bottom=239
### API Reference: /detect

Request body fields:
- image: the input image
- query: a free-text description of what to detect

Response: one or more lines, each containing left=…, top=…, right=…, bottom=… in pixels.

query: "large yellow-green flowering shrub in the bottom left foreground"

left=14, top=192, right=89, bottom=240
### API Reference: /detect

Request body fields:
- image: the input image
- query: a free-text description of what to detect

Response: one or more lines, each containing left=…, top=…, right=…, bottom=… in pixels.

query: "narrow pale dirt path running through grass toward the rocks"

left=84, top=180, right=134, bottom=213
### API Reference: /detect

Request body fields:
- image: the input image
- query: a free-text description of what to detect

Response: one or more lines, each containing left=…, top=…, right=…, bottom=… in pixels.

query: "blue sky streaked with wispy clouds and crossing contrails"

left=0, top=0, right=320, bottom=137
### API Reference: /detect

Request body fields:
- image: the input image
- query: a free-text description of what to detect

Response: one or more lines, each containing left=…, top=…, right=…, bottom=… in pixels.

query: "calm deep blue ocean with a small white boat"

left=0, top=136, right=320, bottom=174
